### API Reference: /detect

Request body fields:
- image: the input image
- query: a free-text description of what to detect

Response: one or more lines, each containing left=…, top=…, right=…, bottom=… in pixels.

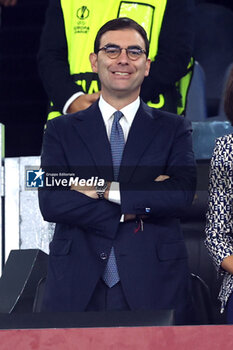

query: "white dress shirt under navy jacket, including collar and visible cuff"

left=99, top=95, right=140, bottom=204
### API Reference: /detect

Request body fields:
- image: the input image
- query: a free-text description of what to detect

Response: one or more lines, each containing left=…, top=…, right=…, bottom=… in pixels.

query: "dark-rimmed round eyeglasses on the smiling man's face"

left=97, top=45, right=146, bottom=61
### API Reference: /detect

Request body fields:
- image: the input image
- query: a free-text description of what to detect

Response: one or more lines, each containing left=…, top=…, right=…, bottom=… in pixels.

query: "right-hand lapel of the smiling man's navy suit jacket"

left=119, top=102, right=159, bottom=182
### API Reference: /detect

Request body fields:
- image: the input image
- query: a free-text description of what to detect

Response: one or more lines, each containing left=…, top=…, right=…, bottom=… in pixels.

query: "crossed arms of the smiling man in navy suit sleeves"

left=39, top=118, right=195, bottom=237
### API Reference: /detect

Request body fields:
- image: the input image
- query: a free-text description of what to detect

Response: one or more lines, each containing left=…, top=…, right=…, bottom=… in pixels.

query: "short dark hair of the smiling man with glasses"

left=94, top=17, right=149, bottom=57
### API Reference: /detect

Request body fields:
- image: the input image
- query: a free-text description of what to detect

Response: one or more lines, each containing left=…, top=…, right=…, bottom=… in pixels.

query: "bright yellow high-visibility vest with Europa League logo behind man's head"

left=48, top=0, right=191, bottom=119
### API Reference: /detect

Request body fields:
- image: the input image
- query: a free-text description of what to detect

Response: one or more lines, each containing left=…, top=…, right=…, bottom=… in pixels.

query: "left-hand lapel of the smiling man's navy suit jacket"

left=74, top=101, right=113, bottom=180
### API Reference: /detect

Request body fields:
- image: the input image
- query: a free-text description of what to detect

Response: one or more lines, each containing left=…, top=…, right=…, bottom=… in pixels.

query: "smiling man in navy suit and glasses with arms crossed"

left=39, top=18, right=196, bottom=323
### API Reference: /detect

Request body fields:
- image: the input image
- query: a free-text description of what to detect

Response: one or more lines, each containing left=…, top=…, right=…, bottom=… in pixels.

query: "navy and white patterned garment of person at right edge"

left=205, top=135, right=233, bottom=312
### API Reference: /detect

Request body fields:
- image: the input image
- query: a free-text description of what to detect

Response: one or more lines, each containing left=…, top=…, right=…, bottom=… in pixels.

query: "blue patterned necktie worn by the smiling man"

left=103, top=111, right=125, bottom=288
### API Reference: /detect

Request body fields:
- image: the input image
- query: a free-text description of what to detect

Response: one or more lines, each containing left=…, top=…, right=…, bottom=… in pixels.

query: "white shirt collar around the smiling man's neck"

left=99, top=95, right=140, bottom=125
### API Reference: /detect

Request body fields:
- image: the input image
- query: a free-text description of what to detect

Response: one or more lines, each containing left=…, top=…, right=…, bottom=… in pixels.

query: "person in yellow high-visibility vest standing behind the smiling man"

left=38, top=0, right=195, bottom=119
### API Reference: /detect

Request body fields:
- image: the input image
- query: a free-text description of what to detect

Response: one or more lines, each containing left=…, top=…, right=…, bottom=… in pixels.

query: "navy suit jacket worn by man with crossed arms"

left=39, top=98, right=196, bottom=320
